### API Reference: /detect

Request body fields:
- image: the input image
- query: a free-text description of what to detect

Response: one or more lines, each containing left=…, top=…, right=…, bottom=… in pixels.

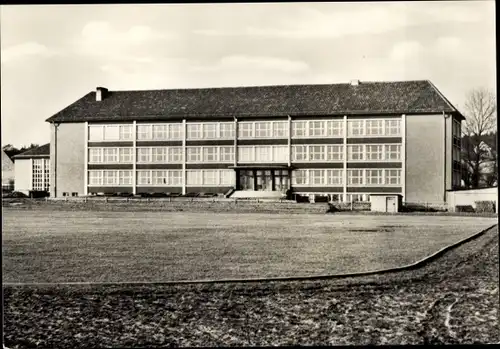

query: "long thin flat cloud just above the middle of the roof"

left=191, top=55, right=310, bottom=73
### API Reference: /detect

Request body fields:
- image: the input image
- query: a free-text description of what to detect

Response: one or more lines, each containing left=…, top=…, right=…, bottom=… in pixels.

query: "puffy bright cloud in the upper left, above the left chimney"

left=76, top=21, right=174, bottom=63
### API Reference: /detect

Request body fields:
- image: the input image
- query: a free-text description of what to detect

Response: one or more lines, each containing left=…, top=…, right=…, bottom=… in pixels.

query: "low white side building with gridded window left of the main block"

left=13, top=143, right=50, bottom=196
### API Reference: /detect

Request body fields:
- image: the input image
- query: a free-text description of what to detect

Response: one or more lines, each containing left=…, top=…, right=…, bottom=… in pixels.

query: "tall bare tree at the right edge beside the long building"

left=462, top=89, right=498, bottom=188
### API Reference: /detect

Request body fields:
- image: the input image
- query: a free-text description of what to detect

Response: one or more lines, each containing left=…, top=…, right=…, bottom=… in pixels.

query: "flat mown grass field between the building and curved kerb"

left=2, top=209, right=497, bottom=283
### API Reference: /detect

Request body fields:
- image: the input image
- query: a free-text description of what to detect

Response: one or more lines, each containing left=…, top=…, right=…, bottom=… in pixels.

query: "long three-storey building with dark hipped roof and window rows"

left=47, top=80, right=464, bottom=203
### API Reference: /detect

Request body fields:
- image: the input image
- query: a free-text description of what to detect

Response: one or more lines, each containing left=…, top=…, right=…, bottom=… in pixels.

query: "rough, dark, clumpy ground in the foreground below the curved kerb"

left=4, top=228, right=500, bottom=348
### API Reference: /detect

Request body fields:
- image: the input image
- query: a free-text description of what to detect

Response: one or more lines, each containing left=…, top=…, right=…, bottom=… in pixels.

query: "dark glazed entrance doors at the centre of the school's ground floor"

left=236, top=169, right=290, bottom=191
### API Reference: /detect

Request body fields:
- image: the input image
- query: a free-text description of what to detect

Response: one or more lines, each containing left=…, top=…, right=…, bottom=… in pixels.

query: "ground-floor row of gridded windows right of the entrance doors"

left=292, top=169, right=401, bottom=186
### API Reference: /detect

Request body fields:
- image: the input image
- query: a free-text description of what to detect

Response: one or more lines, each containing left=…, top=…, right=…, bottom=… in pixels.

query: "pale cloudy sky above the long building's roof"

left=0, top=1, right=496, bottom=146
